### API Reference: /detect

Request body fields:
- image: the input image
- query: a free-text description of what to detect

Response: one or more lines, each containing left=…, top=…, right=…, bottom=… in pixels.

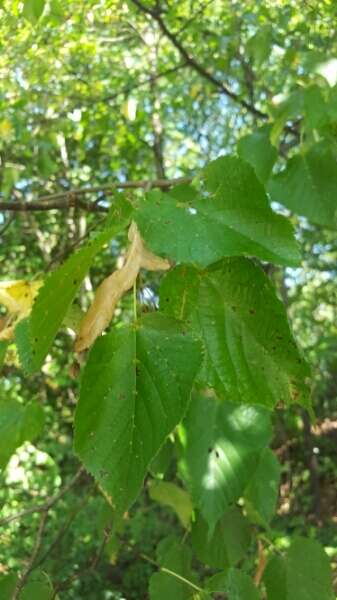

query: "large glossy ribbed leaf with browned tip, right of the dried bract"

left=160, top=258, right=310, bottom=407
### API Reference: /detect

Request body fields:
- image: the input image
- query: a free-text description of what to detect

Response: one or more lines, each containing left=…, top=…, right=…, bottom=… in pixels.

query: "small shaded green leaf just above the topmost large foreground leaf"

left=238, top=125, right=278, bottom=183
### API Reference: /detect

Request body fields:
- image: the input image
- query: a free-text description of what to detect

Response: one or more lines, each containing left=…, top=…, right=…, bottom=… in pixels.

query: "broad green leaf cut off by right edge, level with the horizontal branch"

left=268, top=142, right=337, bottom=228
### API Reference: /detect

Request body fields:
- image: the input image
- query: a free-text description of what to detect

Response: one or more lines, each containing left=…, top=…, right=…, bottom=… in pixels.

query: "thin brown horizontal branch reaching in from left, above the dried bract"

left=0, top=177, right=192, bottom=212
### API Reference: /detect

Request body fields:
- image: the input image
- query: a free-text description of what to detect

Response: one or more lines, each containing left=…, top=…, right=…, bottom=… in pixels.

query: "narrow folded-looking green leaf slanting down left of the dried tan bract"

left=15, top=213, right=130, bottom=373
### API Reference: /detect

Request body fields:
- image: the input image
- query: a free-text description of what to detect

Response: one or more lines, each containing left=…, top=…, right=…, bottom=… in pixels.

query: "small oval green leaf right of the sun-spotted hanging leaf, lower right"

left=244, top=448, right=281, bottom=526
